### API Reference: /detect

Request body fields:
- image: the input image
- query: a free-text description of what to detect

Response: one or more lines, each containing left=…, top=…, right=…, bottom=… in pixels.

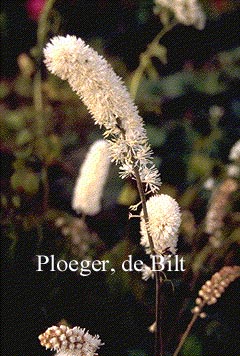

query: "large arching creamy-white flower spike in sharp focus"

left=44, top=35, right=161, bottom=193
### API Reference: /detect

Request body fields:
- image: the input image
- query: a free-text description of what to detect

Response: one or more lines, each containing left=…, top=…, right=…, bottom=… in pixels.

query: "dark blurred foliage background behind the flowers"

left=0, top=0, right=240, bottom=356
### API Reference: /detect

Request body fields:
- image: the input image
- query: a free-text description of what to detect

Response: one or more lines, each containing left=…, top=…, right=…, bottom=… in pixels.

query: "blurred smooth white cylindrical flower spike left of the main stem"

left=72, top=140, right=110, bottom=215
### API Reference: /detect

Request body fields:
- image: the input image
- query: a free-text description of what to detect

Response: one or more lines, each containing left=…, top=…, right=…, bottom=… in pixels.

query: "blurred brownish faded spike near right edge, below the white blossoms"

left=205, top=178, right=238, bottom=235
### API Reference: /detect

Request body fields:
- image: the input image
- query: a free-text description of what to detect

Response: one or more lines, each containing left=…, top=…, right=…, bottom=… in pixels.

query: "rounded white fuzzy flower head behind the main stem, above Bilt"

left=140, top=194, right=181, bottom=255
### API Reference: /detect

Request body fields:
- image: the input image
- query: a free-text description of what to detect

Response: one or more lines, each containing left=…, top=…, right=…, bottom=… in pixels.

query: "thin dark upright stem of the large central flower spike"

left=134, top=167, right=163, bottom=356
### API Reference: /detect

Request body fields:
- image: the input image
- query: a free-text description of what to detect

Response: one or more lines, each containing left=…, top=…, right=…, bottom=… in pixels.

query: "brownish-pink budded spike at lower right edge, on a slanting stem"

left=192, top=266, right=240, bottom=317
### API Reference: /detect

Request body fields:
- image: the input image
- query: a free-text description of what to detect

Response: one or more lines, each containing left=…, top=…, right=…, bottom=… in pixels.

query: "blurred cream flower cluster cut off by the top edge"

left=155, top=0, right=206, bottom=30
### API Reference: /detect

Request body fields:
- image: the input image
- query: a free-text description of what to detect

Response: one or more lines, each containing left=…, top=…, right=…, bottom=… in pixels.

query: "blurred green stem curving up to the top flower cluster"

left=129, top=22, right=176, bottom=99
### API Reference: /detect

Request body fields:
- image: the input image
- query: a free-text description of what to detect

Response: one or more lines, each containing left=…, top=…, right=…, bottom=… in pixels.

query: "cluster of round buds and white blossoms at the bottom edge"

left=38, top=325, right=103, bottom=356
